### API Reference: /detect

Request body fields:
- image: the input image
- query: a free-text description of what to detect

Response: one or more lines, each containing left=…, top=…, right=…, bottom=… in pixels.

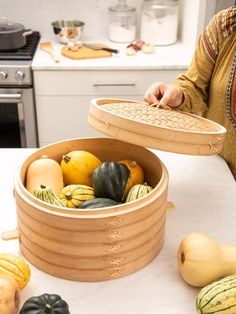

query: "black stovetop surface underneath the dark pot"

left=0, top=32, right=40, bottom=60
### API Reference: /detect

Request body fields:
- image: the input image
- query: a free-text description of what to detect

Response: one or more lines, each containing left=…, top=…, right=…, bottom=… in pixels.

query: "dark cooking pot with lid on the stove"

left=0, top=17, right=32, bottom=51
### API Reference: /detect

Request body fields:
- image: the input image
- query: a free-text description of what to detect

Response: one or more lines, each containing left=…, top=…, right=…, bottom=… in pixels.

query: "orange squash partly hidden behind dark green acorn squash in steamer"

left=119, top=159, right=144, bottom=192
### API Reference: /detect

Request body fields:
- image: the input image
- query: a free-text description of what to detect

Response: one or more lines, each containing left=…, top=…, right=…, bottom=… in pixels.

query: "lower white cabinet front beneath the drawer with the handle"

left=36, top=95, right=142, bottom=147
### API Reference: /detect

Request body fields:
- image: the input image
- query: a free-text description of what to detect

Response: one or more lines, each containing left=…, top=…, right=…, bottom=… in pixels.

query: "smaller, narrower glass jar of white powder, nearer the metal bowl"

left=109, top=0, right=136, bottom=43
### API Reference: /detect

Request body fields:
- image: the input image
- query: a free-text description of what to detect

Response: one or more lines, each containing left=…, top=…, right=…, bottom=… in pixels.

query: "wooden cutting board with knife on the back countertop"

left=61, top=43, right=112, bottom=60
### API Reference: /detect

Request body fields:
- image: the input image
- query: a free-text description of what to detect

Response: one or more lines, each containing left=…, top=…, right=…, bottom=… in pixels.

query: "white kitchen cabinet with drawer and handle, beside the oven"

left=34, top=70, right=183, bottom=147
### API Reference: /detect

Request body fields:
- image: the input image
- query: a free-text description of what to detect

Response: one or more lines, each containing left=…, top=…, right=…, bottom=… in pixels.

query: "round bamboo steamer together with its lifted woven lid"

left=10, top=99, right=226, bottom=281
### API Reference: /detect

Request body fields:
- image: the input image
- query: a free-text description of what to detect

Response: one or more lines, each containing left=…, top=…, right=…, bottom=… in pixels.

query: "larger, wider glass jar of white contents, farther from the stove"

left=140, top=0, right=179, bottom=46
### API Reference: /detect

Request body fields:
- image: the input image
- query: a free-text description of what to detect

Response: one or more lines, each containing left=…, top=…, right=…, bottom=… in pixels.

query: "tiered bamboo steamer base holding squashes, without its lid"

left=14, top=138, right=168, bottom=281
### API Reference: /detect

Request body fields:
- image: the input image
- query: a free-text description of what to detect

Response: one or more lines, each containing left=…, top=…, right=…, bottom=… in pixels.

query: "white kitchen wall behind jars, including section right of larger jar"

left=0, top=0, right=234, bottom=43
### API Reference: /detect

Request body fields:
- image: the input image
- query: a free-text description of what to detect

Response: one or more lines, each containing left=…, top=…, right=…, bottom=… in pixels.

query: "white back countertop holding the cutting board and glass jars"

left=32, top=38, right=193, bottom=71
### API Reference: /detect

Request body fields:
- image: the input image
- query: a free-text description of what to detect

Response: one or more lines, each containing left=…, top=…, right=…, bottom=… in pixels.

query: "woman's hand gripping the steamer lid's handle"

left=144, top=82, right=183, bottom=107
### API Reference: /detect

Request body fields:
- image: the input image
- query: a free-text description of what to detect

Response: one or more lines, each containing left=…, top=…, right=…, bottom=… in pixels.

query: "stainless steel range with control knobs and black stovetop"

left=0, top=32, right=39, bottom=148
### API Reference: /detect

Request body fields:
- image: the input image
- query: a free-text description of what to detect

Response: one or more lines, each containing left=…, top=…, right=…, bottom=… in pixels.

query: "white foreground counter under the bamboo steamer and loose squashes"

left=0, top=149, right=236, bottom=314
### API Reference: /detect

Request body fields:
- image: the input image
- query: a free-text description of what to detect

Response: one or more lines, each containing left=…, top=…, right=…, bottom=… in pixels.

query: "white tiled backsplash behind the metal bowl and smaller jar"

left=0, top=0, right=142, bottom=39
